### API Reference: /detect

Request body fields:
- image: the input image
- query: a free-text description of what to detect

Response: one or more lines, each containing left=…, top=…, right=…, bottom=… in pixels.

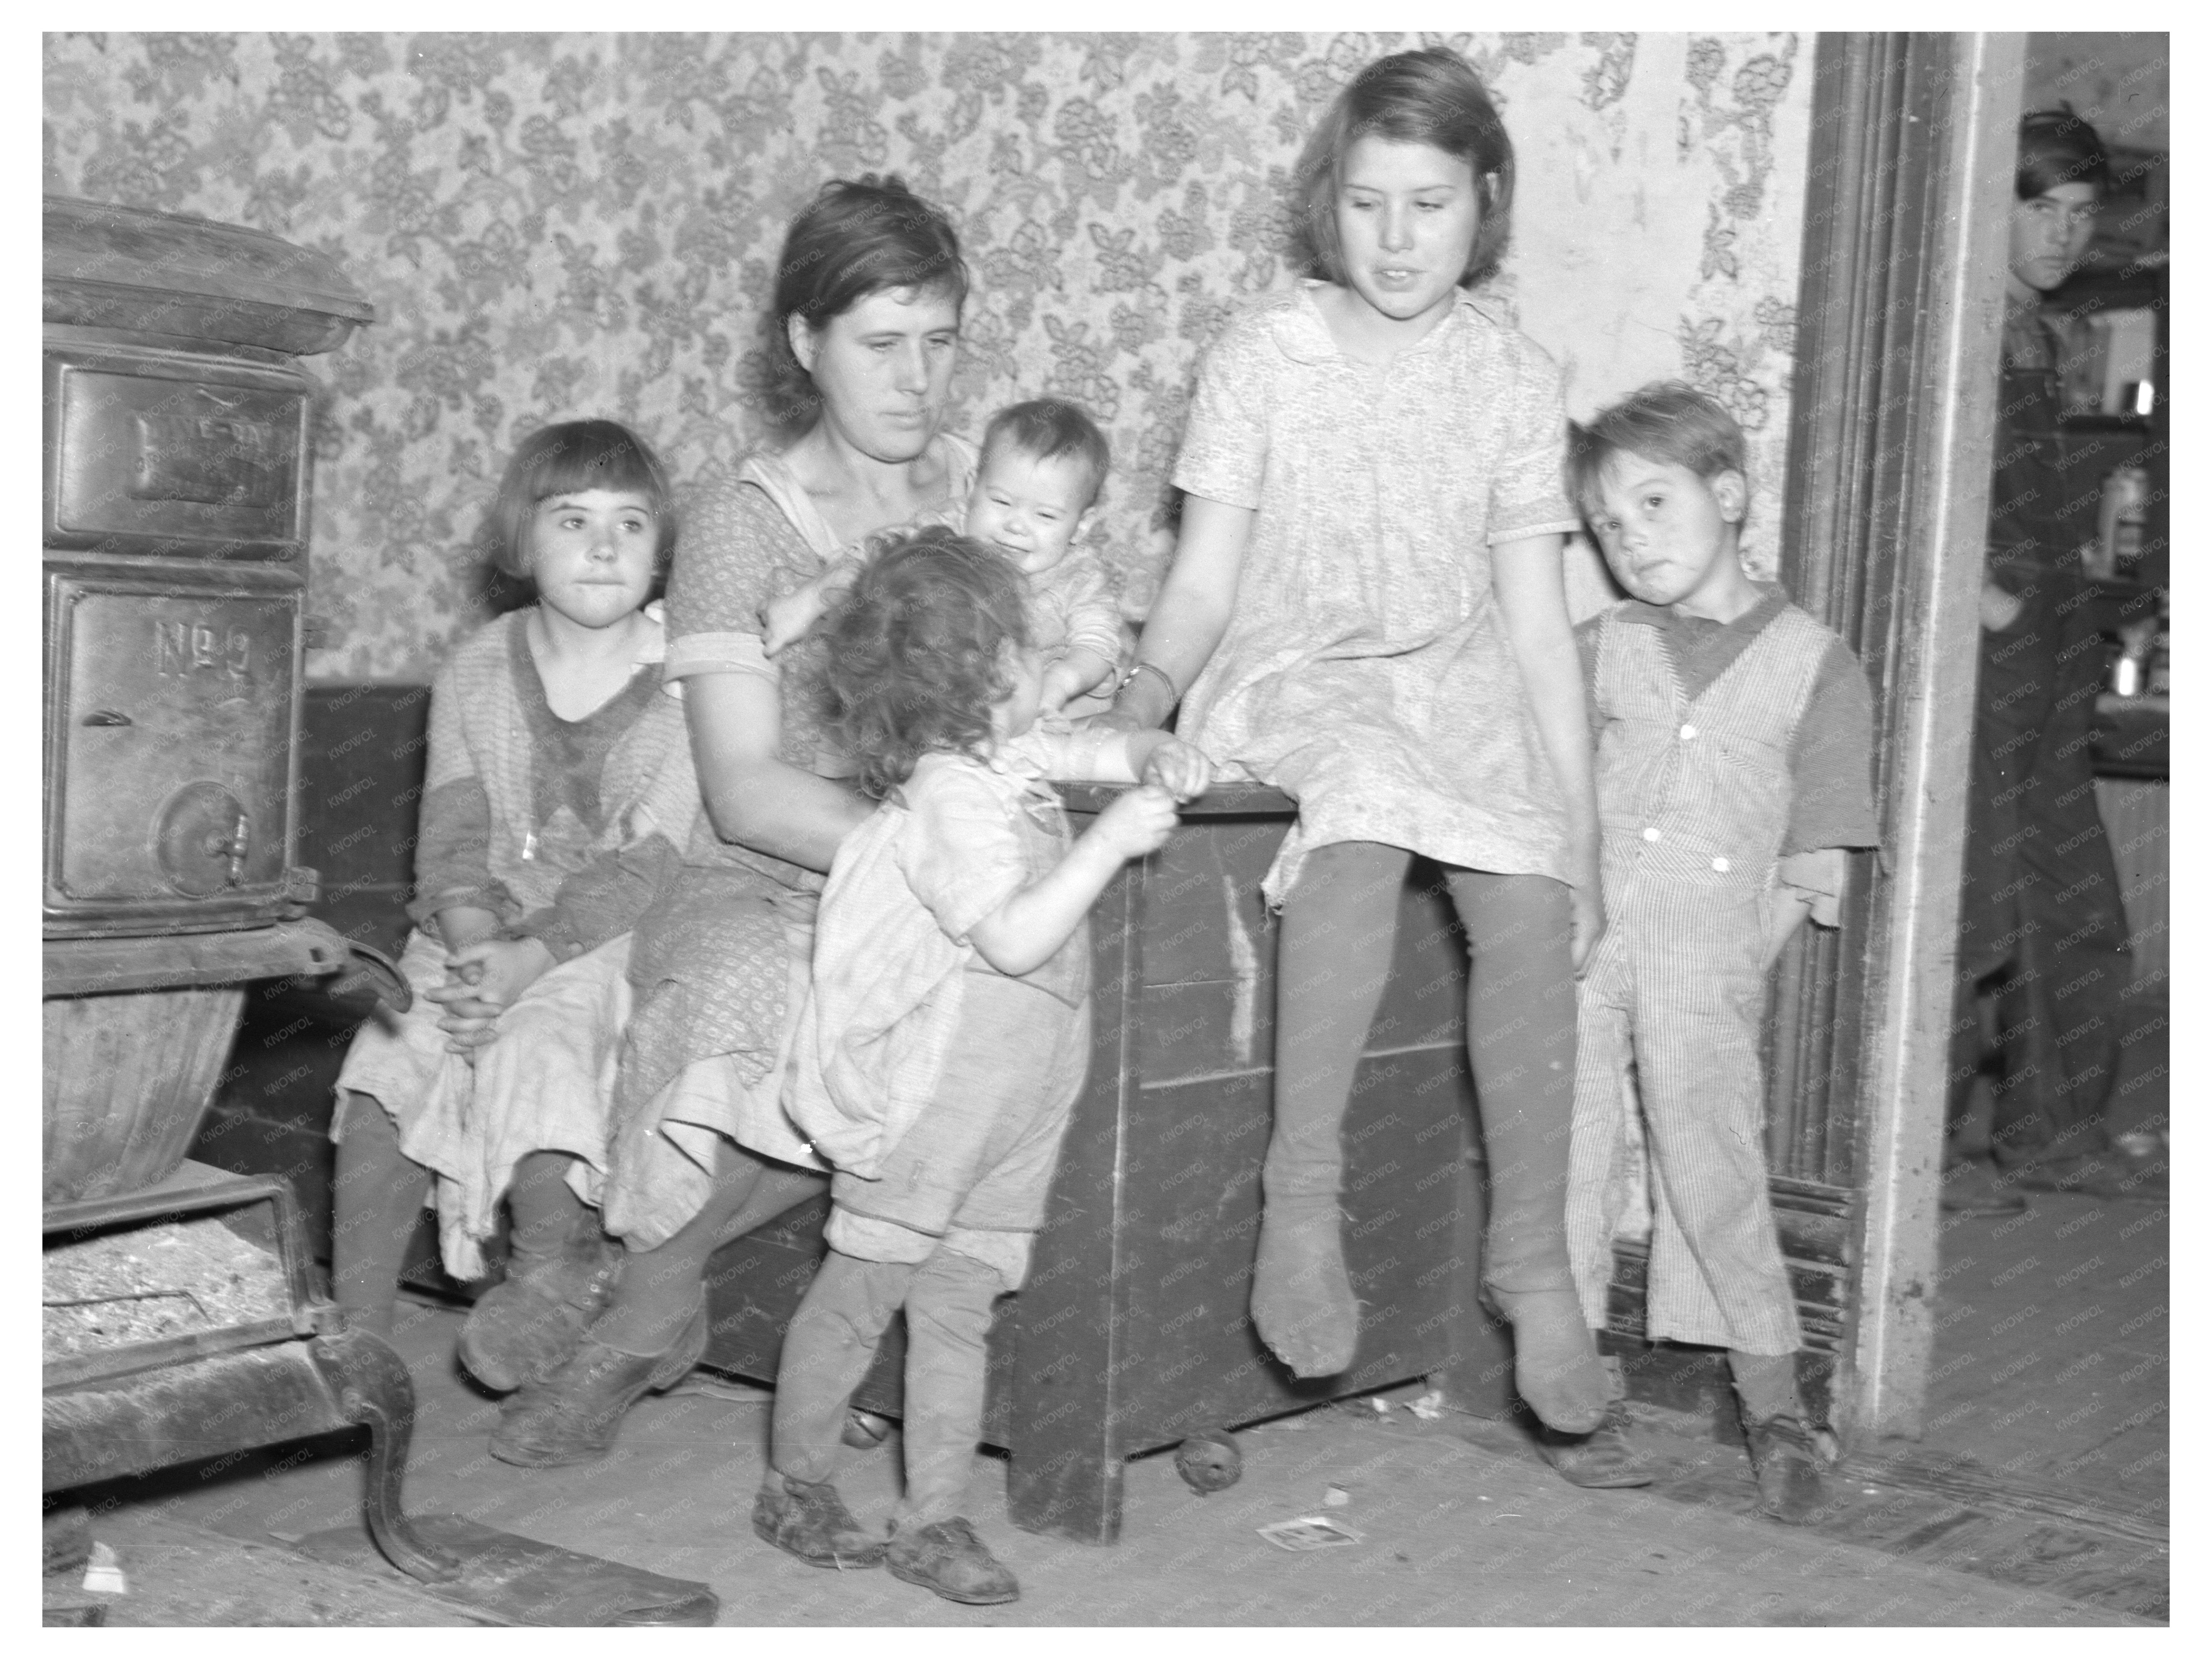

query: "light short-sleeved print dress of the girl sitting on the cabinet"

left=1175, top=281, right=1577, bottom=903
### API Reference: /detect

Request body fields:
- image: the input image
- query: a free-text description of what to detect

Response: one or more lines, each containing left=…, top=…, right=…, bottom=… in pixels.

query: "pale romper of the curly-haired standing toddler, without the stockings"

left=790, top=730, right=1106, bottom=1289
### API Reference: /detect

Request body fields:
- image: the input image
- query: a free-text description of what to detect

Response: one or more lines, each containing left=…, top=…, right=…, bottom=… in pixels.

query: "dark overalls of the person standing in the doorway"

left=1951, top=312, right=2128, bottom=1163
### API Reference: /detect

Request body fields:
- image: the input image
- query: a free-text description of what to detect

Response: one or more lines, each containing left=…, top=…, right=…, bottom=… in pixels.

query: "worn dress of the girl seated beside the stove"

left=332, top=606, right=701, bottom=1279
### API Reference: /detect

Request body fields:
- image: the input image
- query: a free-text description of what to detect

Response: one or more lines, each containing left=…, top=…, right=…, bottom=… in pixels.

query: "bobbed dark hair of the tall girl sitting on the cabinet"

left=1290, top=46, right=1513, bottom=288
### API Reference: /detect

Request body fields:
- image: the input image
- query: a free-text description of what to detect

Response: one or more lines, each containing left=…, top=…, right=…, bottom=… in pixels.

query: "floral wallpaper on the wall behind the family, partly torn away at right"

left=44, top=33, right=1811, bottom=679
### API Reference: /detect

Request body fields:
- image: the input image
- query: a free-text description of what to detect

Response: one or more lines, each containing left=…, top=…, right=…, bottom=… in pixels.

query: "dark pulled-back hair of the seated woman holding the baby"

left=765, top=172, right=967, bottom=427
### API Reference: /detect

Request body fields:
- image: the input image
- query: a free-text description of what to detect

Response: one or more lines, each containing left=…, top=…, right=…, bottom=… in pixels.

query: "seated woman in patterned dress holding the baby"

left=491, top=177, right=975, bottom=1464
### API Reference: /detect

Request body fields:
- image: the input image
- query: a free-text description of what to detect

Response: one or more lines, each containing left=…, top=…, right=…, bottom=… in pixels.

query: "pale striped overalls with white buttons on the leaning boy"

left=1566, top=604, right=1834, bottom=1354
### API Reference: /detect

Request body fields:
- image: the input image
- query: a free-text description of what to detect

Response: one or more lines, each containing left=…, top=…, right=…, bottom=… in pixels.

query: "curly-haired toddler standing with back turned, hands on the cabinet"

left=752, top=529, right=1210, bottom=1604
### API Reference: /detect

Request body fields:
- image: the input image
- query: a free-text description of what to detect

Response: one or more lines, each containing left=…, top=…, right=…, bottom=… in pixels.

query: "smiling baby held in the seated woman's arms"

left=763, top=398, right=1121, bottom=717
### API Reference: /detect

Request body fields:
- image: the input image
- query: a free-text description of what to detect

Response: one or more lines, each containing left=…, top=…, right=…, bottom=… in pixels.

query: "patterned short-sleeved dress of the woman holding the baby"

left=604, top=434, right=978, bottom=1250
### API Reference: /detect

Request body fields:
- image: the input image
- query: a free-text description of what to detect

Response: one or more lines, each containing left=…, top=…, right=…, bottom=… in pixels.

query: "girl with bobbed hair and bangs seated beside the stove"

left=332, top=420, right=699, bottom=1389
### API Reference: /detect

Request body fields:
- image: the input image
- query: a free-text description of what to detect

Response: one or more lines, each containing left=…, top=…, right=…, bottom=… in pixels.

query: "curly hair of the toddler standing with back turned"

left=823, top=527, right=1031, bottom=801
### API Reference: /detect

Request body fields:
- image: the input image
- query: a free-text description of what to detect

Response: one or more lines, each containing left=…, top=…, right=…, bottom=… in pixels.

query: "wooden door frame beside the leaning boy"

left=1770, top=33, right=2026, bottom=1444
